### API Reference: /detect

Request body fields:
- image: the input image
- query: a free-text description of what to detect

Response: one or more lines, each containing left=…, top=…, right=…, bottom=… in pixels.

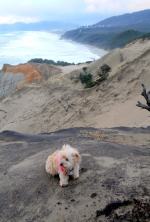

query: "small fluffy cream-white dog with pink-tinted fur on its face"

left=45, top=144, right=81, bottom=186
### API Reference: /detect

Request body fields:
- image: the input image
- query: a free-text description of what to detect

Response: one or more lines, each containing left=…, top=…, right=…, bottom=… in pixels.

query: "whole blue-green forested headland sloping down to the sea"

left=62, top=10, right=150, bottom=49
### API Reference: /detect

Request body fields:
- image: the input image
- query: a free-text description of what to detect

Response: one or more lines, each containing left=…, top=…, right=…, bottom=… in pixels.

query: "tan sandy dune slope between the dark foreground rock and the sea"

left=0, top=40, right=150, bottom=133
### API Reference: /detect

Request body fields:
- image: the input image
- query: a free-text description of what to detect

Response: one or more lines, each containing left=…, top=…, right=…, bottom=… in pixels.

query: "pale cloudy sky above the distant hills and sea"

left=0, top=0, right=150, bottom=24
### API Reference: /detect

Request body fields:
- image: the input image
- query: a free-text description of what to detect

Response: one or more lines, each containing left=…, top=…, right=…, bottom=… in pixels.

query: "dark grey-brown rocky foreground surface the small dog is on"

left=0, top=128, right=150, bottom=222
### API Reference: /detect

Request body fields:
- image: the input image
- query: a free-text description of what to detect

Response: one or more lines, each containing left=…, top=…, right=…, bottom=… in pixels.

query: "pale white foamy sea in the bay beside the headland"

left=0, top=31, right=106, bottom=67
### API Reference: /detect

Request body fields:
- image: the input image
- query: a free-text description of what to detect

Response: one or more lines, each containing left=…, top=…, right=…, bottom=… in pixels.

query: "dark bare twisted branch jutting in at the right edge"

left=136, top=84, right=150, bottom=112
